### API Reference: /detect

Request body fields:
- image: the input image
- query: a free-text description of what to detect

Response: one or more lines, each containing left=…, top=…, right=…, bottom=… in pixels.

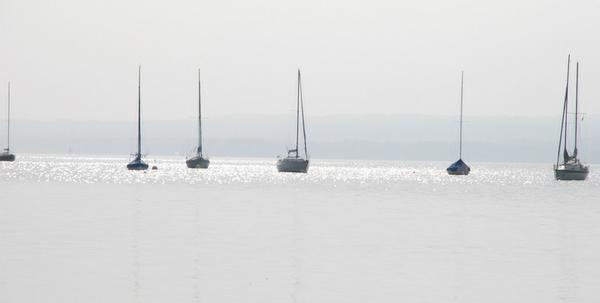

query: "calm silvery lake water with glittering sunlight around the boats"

left=0, top=155, right=600, bottom=303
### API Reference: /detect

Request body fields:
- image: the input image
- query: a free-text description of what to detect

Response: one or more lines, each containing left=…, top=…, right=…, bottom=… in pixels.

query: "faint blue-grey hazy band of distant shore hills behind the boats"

left=0, top=113, right=600, bottom=163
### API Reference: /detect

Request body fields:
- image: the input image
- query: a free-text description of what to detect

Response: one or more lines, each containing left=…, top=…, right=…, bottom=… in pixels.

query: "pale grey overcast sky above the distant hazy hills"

left=0, top=0, right=600, bottom=120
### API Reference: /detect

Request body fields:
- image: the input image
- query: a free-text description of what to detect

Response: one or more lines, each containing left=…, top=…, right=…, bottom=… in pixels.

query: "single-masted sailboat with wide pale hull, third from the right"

left=277, top=69, right=309, bottom=173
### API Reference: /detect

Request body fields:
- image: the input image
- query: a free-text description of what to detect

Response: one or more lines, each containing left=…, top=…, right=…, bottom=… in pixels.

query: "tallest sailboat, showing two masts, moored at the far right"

left=554, top=55, right=590, bottom=181
